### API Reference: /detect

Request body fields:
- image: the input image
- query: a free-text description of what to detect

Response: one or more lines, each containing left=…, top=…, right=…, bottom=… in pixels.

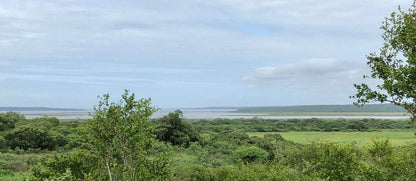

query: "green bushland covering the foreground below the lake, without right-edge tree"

left=0, top=107, right=416, bottom=180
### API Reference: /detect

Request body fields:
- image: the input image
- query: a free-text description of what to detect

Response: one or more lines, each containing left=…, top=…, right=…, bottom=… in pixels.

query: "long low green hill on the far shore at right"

left=238, top=104, right=406, bottom=113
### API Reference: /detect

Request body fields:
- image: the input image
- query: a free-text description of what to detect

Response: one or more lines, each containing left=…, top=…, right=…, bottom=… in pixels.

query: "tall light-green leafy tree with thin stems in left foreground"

left=87, top=90, right=169, bottom=180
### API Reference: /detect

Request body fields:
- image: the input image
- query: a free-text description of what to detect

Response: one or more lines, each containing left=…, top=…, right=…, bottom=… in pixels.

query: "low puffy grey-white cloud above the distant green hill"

left=243, top=58, right=367, bottom=88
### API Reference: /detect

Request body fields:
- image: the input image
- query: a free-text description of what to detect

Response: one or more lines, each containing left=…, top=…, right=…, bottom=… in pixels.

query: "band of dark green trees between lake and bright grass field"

left=190, top=118, right=415, bottom=132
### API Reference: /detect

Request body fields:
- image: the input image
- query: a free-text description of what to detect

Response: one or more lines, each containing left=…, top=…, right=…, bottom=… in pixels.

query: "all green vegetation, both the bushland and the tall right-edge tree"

left=0, top=0, right=416, bottom=181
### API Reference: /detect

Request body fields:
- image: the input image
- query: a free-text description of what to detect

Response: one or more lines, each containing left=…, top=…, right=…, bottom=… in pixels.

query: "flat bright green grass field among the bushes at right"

left=248, top=130, right=416, bottom=147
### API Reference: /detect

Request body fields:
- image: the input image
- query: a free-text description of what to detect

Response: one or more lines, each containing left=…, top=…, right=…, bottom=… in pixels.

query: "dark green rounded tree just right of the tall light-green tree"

left=156, top=110, right=199, bottom=147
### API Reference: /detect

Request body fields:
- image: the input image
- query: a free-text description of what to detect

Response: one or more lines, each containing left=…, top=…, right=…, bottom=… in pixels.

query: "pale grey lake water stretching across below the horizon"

left=0, top=108, right=409, bottom=120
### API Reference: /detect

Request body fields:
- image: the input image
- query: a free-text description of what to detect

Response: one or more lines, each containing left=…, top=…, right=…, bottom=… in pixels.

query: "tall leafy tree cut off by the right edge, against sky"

left=351, top=1, right=416, bottom=122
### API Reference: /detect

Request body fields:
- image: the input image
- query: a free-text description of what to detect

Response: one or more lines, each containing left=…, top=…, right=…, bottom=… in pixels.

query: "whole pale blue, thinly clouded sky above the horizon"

left=0, top=0, right=411, bottom=108
